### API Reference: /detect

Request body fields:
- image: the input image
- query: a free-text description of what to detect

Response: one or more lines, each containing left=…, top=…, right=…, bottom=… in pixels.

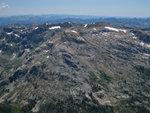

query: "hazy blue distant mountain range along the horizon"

left=0, top=14, right=150, bottom=28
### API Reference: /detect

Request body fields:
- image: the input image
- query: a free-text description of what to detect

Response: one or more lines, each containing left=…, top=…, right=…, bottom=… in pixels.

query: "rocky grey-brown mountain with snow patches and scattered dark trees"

left=0, top=22, right=150, bottom=113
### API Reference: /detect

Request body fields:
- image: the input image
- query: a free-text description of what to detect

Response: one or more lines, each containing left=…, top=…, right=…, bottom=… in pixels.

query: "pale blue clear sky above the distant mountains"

left=0, top=0, right=150, bottom=17
